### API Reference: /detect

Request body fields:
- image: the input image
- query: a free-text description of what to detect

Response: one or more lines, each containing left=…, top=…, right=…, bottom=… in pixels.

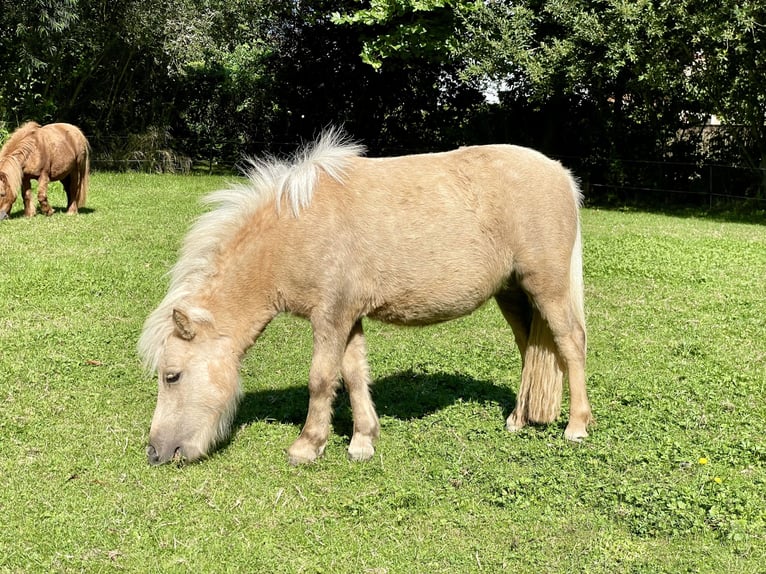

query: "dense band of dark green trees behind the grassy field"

left=0, top=0, right=766, bottom=201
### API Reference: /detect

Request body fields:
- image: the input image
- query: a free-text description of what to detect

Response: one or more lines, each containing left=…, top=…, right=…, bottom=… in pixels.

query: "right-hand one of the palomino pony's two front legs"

left=341, top=320, right=380, bottom=460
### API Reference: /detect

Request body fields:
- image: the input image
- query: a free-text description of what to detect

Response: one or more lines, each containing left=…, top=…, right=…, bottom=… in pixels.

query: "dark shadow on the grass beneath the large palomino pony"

left=235, top=370, right=516, bottom=437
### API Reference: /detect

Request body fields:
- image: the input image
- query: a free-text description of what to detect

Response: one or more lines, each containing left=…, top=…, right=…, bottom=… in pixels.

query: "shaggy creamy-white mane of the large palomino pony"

left=138, top=129, right=365, bottom=372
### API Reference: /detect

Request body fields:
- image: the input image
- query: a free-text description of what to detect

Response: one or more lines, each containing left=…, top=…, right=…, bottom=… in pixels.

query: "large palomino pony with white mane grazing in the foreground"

left=138, top=132, right=591, bottom=464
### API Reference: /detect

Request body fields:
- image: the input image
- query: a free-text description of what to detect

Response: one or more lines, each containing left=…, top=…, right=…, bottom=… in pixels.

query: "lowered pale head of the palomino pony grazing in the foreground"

left=140, top=308, right=242, bottom=464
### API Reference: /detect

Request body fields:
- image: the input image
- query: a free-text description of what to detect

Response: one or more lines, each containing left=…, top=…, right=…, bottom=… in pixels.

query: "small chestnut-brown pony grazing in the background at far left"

left=0, top=122, right=90, bottom=220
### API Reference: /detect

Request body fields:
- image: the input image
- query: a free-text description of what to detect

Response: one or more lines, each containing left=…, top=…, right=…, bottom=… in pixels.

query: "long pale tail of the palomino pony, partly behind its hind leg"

left=508, top=180, right=585, bottom=430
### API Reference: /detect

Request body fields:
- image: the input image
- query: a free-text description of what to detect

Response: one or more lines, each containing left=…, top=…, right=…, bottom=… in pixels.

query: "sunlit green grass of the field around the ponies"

left=0, top=178, right=766, bottom=574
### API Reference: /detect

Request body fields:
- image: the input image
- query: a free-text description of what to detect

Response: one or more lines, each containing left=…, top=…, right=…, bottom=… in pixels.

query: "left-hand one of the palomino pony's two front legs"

left=287, top=321, right=351, bottom=465
